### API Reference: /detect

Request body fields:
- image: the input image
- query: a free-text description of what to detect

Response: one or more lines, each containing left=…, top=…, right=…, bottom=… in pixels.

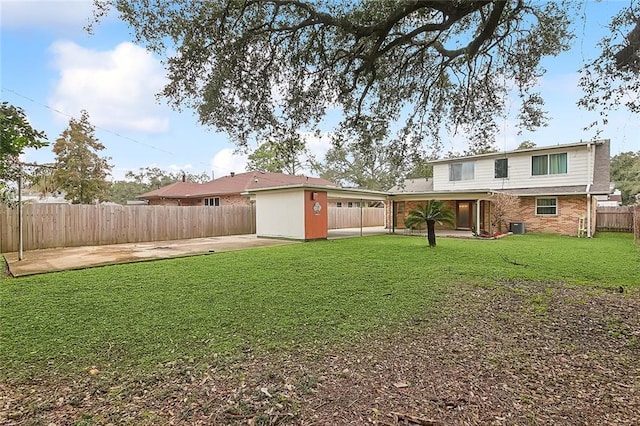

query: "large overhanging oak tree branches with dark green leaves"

left=95, top=0, right=638, bottom=154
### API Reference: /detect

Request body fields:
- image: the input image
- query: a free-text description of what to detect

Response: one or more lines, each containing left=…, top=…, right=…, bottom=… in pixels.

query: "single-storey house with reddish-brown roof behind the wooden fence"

left=136, top=172, right=338, bottom=207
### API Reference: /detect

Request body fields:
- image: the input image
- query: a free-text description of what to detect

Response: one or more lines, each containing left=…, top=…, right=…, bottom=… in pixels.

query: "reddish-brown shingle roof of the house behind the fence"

left=137, top=172, right=338, bottom=199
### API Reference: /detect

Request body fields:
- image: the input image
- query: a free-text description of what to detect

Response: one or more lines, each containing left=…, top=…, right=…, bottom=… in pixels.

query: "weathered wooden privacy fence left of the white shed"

left=0, top=204, right=255, bottom=253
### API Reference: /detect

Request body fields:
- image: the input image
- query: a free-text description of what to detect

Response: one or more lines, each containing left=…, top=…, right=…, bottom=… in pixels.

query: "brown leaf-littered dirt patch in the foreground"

left=0, top=281, right=640, bottom=425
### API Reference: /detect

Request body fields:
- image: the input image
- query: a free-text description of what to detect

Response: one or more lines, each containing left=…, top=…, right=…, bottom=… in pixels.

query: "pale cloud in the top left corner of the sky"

left=0, top=0, right=93, bottom=32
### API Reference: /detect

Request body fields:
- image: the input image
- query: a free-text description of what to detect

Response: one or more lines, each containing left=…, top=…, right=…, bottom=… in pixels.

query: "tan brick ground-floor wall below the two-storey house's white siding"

left=507, top=195, right=595, bottom=235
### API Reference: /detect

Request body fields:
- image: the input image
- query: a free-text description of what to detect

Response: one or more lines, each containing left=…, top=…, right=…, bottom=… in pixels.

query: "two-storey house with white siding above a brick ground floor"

left=386, top=140, right=610, bottom=236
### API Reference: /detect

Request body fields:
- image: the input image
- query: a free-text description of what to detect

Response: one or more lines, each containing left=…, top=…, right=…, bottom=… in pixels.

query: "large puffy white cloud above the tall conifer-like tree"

left=49, top=41, right=169, bottom=133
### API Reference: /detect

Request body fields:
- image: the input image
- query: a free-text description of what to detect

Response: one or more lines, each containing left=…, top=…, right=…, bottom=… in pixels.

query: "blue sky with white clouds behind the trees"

left=0, top=0, right=640, bottom=180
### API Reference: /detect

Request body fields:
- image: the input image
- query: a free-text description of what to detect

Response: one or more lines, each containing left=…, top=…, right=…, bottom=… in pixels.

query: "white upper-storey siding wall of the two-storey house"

left=433, top=146, right=593, bottom=191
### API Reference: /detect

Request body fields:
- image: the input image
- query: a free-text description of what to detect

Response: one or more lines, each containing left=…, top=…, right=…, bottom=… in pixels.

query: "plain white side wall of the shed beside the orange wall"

left=255, top=190, right=305, bottom=240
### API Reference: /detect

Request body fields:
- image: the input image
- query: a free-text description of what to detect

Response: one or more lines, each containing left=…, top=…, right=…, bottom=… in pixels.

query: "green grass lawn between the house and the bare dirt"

left=0, top=234, right=640, bottom=381
